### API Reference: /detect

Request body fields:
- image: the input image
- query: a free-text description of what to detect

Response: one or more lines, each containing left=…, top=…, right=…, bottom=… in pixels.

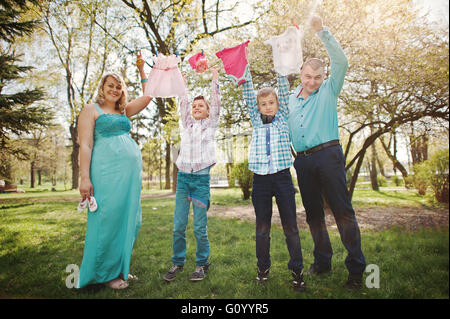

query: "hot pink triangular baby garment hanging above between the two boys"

left=216, top=41, right=250, bottom=85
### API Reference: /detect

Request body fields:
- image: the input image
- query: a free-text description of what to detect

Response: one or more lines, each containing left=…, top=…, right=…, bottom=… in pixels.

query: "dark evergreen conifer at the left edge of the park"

left=0, top=0, right=53, bottom=181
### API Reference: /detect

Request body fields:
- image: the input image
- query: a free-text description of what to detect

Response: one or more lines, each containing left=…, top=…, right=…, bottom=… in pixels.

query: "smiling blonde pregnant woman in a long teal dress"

left=77, top=64, right=151, bottom=289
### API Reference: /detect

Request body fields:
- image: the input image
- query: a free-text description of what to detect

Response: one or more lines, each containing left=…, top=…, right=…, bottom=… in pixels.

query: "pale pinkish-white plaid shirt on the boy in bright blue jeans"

left=176, top=81, right=220, bottom=173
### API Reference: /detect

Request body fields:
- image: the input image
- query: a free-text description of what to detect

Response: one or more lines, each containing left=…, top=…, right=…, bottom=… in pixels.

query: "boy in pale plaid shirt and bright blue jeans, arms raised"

left=163, top=67, right=220, bottom=282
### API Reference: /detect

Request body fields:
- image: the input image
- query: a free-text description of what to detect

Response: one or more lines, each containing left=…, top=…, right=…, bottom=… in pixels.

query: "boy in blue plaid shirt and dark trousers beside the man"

left=243, top=48, right=306, bottom=291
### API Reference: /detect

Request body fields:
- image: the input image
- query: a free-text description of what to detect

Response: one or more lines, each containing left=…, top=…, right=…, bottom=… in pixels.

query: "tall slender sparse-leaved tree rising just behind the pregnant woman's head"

left=39, top=0, right=118, bottom=189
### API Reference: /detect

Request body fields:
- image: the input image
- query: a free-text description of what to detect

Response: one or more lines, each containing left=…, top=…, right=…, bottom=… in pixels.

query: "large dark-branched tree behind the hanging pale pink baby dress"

left=122, top=0, right=268, bottom=189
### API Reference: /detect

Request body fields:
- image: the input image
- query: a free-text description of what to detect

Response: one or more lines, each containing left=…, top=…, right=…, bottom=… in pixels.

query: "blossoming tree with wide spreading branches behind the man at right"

left=224, top=0, right=449, bottom=199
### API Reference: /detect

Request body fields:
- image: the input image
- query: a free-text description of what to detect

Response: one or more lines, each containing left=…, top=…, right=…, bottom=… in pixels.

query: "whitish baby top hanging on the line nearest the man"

left=264, top=26, right=303, bottom=76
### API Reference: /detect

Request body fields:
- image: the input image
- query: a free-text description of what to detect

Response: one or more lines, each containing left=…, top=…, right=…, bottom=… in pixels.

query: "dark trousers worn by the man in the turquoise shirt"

left=294, top=145, right=366, bottom=275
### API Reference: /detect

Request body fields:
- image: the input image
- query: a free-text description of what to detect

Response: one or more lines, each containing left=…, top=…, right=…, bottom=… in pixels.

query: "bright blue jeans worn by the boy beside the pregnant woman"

left=172, top=172, right=210, bottom=266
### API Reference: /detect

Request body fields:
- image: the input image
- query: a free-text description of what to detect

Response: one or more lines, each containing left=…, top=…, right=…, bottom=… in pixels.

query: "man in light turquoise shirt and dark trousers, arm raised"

left=288, top=17, right=366, bottom=289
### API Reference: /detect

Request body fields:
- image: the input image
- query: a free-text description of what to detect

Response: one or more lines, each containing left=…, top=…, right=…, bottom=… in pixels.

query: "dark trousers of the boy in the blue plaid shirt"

left=252, top=169, right=303, bottom=271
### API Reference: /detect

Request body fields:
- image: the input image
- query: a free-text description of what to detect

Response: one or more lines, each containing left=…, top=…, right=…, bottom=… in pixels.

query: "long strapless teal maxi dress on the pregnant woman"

left=77, top=104, right=142, bottom=288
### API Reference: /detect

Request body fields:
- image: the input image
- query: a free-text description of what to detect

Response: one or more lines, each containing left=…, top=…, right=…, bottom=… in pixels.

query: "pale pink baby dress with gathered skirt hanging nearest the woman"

left=144, top=54, right=186, bottom=98
